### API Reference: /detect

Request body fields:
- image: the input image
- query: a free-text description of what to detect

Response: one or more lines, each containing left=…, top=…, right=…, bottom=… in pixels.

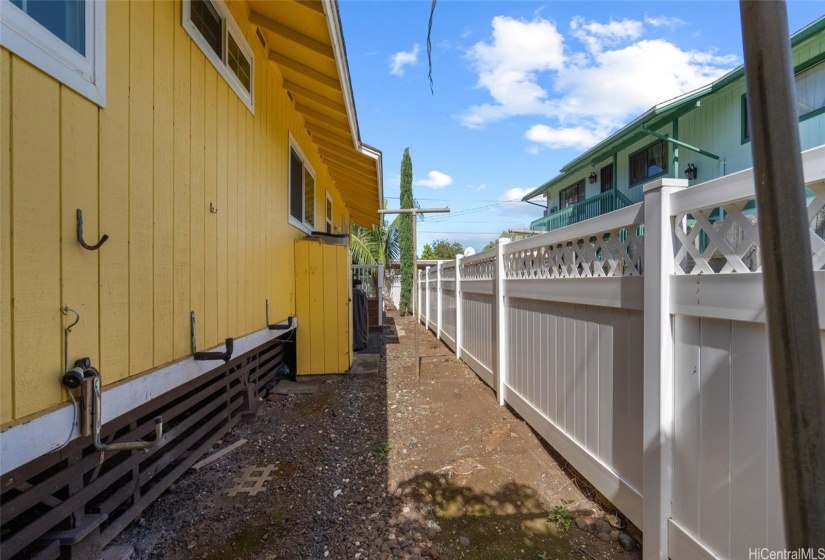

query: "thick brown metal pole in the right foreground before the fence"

left=739, top=0, right=825, bottom=550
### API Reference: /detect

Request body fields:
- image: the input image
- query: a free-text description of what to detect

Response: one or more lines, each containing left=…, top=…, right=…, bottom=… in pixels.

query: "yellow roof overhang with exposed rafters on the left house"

left=248, top=0, right=384, bottom=227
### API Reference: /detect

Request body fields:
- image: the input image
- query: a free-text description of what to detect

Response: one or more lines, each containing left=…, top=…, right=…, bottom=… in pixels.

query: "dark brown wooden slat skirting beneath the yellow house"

left=0, top=332, right=295, bottom=560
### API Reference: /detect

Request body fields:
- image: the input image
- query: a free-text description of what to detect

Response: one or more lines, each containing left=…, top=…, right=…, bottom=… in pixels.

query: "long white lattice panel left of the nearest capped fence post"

left=504, top=228, right=644, bottom=280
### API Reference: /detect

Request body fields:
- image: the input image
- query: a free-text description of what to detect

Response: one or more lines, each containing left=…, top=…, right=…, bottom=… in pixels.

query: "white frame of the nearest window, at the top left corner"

left=0, top=0, right=106, bottom=107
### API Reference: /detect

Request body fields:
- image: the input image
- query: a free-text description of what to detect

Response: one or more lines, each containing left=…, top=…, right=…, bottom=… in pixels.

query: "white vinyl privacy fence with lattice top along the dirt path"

left=418, top=148, right=825, bottom=560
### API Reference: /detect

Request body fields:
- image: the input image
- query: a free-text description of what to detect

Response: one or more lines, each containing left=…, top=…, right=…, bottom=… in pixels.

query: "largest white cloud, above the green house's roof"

left=459, top=16, right=739, bottom=153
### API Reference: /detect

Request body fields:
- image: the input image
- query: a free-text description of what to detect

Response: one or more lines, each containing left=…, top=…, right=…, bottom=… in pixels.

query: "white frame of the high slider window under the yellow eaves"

left=181, top=0, right=255, bottom=115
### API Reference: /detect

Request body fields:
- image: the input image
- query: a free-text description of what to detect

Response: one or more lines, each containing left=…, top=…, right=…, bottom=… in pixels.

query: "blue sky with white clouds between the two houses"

left=340, top=0, right=825, bottom=251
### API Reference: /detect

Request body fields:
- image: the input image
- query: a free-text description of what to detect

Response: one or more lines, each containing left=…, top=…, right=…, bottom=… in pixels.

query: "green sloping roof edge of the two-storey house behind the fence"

left=522, top=16, right=825, bottom=201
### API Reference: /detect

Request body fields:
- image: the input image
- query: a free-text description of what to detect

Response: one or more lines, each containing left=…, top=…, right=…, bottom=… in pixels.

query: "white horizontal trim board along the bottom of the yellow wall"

left=0, top=318, right=298, bottom=475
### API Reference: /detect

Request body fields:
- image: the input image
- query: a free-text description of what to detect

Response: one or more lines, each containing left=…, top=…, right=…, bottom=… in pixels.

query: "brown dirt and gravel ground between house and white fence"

left=113, top=313, right=640, bottom=560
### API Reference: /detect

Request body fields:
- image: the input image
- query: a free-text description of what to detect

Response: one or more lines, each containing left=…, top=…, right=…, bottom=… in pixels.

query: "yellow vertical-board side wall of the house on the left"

left=0, top=1, right=349, bottom=425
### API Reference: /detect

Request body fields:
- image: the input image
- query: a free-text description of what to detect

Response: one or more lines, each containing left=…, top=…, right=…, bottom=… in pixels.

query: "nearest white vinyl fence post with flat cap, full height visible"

left=642, top=179, right=688, bottom=560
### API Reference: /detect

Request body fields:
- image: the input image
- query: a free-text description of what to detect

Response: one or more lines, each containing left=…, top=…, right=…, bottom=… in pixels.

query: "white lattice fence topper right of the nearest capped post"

left=673, top=189, right=825, bottom=274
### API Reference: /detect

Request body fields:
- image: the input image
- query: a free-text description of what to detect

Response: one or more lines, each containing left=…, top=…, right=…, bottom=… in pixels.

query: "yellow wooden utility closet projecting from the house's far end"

left=295, top=239, right=352, bottom=375
